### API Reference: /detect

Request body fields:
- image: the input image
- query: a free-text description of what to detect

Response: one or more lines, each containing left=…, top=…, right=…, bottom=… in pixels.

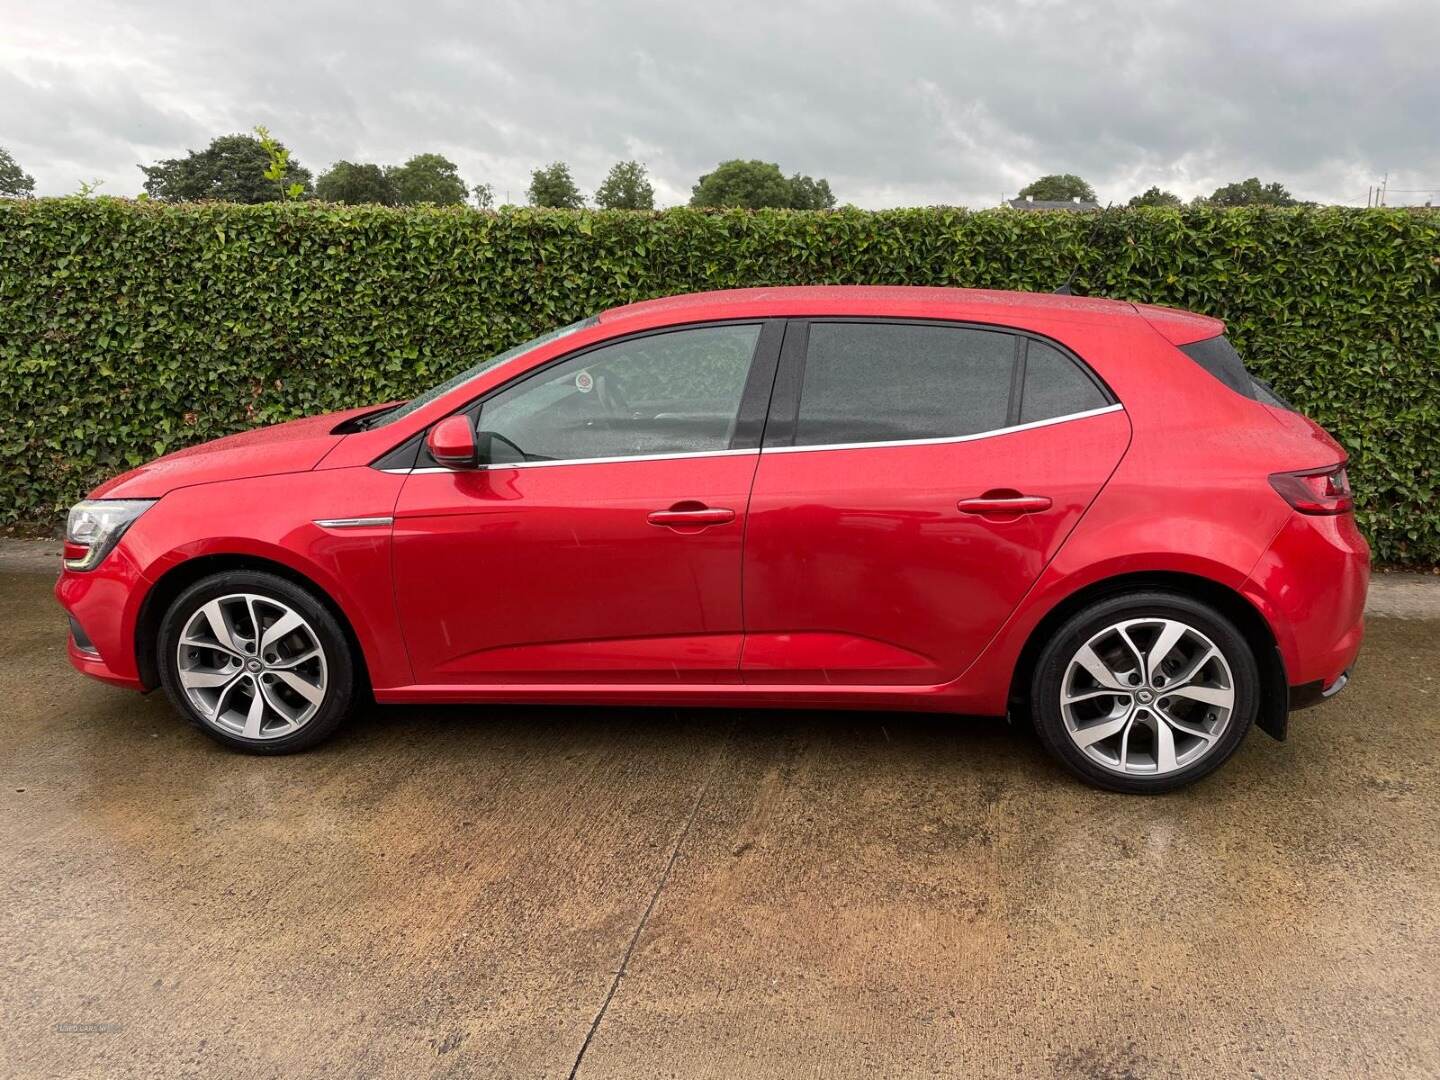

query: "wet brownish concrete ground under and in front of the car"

left=0, top=546, right=1440, bottom=1079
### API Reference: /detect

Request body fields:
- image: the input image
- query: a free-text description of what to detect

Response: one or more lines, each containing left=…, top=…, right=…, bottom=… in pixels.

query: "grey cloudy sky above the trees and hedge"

left=0, top=0, right=1440, bottom=207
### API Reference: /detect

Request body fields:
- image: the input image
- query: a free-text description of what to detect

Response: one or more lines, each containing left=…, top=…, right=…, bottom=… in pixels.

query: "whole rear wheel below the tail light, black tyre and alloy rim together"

left=1030, top=592, right=1260, bottom=795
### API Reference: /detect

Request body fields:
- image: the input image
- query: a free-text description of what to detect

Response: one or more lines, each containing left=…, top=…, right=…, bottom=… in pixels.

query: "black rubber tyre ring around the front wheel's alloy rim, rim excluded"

left=157, top=570, right=356, bottom=755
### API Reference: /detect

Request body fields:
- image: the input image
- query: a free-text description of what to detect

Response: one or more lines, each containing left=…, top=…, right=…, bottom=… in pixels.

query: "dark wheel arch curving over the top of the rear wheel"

left=1009, top=570, right=1290, bottom=740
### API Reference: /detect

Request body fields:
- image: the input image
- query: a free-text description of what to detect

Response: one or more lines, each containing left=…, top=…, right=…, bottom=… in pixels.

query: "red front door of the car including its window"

left=393, top=323, right=780, bottom=684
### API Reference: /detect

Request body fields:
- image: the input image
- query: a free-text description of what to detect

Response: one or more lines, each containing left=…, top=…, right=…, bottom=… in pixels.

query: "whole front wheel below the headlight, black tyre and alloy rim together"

left=158, top=570, right=359, bottom=755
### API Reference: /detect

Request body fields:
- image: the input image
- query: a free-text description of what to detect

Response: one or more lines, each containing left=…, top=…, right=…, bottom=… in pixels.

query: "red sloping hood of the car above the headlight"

left=89, top=405, right=374, bottom=498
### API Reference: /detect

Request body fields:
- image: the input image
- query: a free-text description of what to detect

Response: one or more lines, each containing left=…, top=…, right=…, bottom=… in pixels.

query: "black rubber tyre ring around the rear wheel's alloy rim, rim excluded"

left=1031, top=592, right=1260, bottom=793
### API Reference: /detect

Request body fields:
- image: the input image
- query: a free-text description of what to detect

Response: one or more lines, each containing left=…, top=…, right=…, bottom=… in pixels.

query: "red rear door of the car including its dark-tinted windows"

left=742, top=320, right=1129, bottom=685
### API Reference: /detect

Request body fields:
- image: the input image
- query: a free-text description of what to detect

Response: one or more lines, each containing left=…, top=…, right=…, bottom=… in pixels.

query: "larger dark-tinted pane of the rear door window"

left=795, top=323, right=1015, bottom=446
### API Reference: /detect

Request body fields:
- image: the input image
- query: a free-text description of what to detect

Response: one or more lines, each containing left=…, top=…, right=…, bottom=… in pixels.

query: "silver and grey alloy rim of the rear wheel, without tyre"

left=1060, top=616, right=1236, bottom=776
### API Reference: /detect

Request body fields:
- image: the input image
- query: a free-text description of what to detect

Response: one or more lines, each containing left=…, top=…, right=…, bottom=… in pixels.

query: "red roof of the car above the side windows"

left=599, top=285, right=1224, bottom=341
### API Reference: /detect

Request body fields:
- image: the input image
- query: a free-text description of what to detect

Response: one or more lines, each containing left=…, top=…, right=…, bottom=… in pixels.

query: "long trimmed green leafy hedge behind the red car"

left=0, top=199, right=1440, bottom=563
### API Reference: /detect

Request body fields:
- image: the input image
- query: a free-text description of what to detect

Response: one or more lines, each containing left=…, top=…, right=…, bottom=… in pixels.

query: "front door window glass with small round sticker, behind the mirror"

left=478, top=324, right=760, bottom=462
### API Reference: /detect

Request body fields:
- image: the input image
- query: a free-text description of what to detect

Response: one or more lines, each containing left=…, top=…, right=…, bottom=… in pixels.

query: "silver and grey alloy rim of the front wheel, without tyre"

left=176, top=593, right=328, bottom=740
